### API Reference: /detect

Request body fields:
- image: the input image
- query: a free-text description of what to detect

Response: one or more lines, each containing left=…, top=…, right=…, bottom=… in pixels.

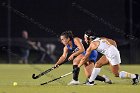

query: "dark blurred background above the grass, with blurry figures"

left=0, top=0, right=140, bottom=64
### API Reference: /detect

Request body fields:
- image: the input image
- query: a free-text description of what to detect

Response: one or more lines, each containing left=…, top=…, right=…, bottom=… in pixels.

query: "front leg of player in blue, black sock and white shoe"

left=68, top=54, right=83, bottom=85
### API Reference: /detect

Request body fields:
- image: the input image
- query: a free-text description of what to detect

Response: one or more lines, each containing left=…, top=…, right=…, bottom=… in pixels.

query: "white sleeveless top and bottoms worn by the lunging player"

left=92, top=38, right=121, bottom=65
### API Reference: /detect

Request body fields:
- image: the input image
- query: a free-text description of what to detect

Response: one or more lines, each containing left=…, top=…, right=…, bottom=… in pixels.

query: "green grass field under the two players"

left=0, top=64, right=140, bottom=93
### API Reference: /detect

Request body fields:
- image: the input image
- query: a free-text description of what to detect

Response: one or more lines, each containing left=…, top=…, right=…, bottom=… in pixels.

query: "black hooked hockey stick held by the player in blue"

left=32, top=61, right=68, bottom=79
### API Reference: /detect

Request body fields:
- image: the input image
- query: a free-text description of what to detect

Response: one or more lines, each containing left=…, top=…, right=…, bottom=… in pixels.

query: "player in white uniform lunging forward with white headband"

left=78, top=30, right=139, bottom=85
